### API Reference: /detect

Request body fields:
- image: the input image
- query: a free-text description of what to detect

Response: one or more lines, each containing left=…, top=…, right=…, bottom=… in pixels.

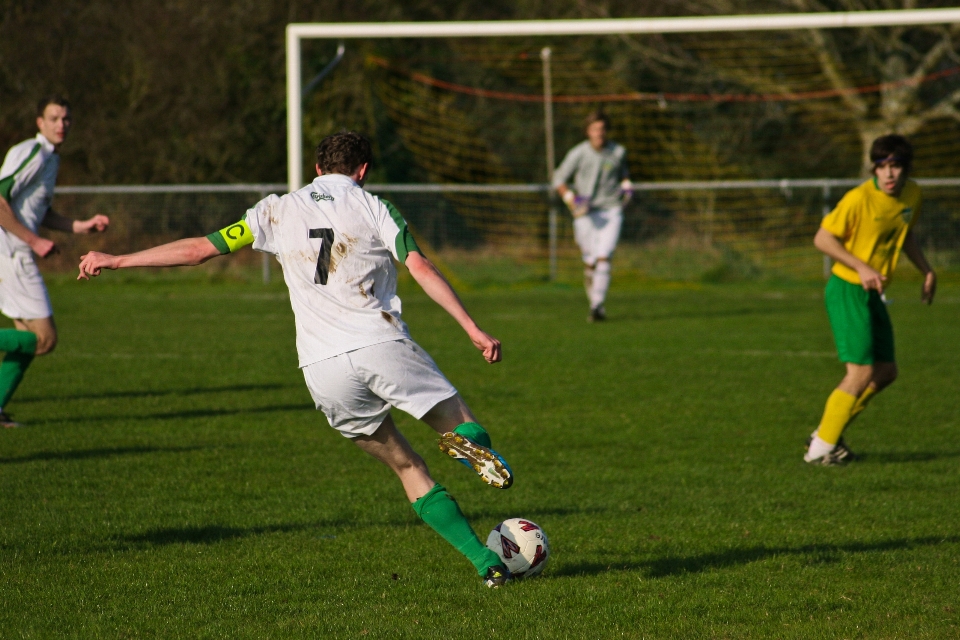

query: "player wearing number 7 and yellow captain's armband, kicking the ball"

left=79, top=132, right=513, bottom=587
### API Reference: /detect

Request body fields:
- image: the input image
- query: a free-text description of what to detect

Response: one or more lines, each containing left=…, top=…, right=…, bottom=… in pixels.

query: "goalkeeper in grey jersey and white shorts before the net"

left=553, top=110, right=633, bottom=322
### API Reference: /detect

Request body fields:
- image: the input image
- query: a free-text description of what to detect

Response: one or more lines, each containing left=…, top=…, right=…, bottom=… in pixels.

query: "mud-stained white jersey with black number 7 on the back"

left=244, top=174, right=419, bottom=367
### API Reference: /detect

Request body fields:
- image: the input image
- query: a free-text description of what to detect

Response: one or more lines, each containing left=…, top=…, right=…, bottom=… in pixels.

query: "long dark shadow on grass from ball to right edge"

left=553, top=536, right=960, bottom=578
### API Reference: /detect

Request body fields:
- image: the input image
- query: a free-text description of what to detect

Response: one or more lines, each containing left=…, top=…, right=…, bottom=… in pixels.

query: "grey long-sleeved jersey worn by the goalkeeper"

left=553, top=140, right=630, bottom=209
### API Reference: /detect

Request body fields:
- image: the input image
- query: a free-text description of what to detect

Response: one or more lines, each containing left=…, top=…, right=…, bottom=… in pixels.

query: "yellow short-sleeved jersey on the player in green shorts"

left=820, top=178, right=922, bottom=284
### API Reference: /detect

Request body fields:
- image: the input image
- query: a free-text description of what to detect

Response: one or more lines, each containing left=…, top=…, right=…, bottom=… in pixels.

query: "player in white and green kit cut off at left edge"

left=0, top=96, right=110, bottom=427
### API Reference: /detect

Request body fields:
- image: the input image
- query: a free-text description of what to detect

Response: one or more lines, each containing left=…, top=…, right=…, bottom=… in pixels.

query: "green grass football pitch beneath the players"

left=0, top=274, right=960, bottom=639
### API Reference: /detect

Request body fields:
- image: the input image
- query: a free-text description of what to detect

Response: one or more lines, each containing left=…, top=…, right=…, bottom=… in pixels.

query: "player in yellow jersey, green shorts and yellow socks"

left=804, top=135, right=937, bottom=466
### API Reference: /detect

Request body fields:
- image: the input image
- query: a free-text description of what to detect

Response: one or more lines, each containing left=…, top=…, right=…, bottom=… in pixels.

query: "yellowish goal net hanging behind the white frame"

left=288, top=11, right=960, bottom=279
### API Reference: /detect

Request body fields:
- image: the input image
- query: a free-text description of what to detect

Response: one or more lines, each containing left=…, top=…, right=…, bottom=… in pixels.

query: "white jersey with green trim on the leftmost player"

left=0, top=133, right=60, bottom=255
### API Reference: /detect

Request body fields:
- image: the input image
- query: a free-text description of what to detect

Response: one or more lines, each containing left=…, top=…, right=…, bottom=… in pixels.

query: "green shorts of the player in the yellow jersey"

left=824, top=275, right=895, bottom=364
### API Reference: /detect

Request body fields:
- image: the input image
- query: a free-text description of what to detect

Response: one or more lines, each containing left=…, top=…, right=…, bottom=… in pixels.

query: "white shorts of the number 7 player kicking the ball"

left=303, top=339, right=457, bottom=438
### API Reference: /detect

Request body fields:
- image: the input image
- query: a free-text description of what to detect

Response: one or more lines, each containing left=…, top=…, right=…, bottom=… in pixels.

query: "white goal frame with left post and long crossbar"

left=287, top=8, right=960, bottom=191
